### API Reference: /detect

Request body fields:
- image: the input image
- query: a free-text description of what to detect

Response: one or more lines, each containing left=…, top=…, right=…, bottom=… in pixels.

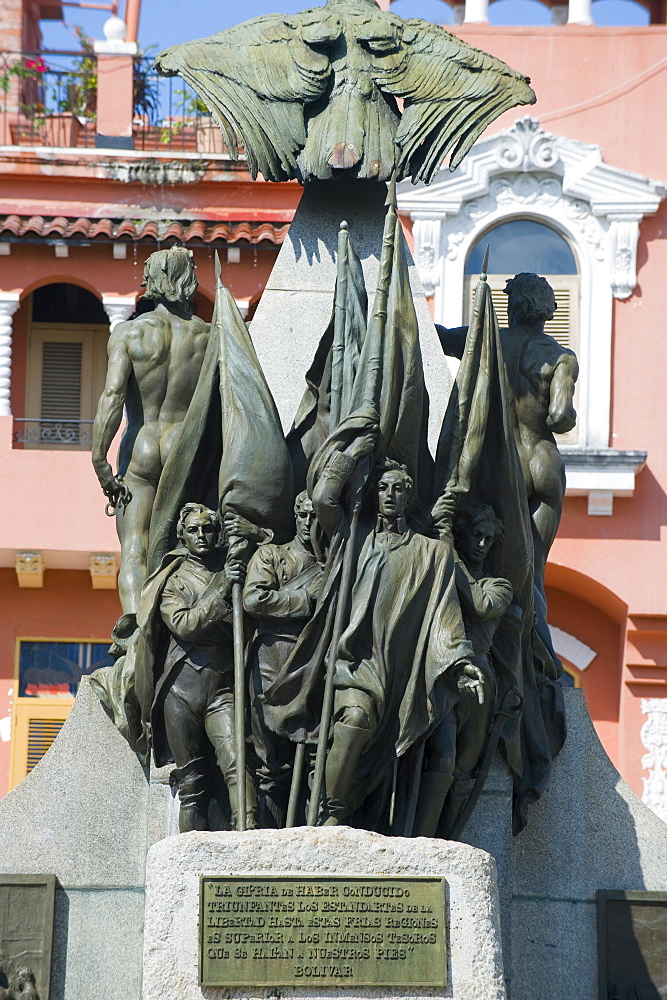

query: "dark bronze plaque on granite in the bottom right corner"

left=597, top=891, right=667, bottom=1000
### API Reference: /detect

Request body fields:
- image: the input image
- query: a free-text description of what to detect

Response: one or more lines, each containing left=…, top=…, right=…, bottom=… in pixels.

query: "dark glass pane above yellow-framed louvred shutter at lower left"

left=19, top=641, right=113, bottom=698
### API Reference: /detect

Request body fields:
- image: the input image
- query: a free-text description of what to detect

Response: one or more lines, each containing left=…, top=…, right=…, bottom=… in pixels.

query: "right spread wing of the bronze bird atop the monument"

left=366, top=19, right=535, bottom=184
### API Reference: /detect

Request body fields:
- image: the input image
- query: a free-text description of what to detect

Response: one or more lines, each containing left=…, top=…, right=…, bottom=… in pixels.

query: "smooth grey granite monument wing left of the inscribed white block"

left=0, top=677, right=149, bottom=1000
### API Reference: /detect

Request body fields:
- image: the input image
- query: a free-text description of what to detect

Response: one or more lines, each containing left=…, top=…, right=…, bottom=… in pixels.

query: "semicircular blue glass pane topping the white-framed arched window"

left=466, top=219, right=577, bottom=274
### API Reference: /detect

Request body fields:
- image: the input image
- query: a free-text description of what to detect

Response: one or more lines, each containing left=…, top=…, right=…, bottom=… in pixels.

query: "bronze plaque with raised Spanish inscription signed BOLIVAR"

left=199, top=875, right=447, bottom=988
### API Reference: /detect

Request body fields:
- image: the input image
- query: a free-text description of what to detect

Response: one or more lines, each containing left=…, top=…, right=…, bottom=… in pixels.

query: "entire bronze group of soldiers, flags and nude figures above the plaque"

left=93, top=186, right=577, bottom=839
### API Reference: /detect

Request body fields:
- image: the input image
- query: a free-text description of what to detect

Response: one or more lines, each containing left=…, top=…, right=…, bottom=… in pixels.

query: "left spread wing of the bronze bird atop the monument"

left=155, top=9, right=340, bottom=181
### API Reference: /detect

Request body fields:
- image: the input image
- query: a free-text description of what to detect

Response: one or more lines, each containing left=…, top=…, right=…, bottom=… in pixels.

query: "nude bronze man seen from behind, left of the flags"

left=91, top=247, right=209, bottom=615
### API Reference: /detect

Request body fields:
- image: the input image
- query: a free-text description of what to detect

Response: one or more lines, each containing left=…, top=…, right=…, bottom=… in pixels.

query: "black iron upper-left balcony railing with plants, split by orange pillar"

left=0, top=51, right=230, bottom=155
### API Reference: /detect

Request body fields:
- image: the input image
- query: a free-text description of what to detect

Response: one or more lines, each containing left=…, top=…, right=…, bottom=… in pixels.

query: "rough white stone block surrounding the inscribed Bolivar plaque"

left=143, top=827, right=506, bottom=1000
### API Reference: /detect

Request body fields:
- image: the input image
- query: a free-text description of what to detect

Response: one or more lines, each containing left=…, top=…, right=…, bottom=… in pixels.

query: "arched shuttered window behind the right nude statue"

left=464, top=218, right=580, bottom=444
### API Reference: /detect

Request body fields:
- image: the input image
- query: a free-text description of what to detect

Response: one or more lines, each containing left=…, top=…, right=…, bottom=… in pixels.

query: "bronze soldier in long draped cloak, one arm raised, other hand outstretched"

left=313, top=434, right=480, bottom=825
